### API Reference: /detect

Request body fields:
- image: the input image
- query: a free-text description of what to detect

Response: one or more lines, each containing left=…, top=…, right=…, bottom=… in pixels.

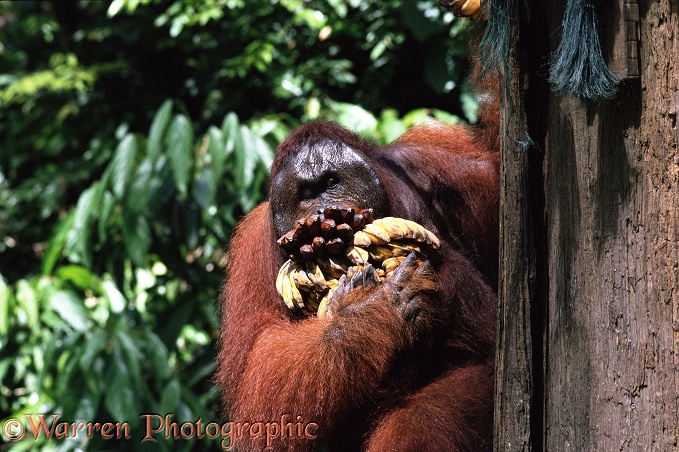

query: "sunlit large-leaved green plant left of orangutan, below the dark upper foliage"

left=0, top=102, right=288, bottom=450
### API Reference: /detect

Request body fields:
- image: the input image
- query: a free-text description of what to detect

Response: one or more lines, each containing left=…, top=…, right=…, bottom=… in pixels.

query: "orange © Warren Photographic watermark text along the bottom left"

left=2, top=413, right=318, bottom=450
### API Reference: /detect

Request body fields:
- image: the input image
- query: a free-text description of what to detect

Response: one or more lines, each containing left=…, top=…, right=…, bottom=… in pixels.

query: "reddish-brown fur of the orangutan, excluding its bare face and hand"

left=217, top=95, right=499, bottom=452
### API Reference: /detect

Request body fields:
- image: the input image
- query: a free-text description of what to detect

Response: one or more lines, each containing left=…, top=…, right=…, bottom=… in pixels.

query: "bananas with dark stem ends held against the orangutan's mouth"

left=276, top=206, right=440, bottom=317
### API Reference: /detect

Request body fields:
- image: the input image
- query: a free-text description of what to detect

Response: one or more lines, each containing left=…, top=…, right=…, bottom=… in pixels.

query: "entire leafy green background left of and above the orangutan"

left=0, top=0, right=476, bottom=450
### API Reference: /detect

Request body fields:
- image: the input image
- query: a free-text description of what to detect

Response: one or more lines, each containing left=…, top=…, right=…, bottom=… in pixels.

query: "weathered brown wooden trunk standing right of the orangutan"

left=496, top=0, right=679, bottom=451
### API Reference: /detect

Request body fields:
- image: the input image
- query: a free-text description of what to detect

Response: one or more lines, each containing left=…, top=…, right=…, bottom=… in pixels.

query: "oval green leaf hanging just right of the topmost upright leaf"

left=165, top=115, right=193, bottom=196
